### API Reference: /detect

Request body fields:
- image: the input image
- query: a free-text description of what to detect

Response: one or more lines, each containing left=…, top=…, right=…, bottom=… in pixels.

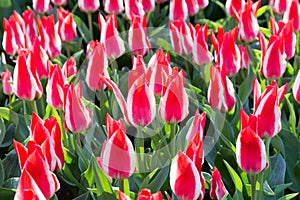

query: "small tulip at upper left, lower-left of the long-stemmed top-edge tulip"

left=56, top=7, right=77, bottom=42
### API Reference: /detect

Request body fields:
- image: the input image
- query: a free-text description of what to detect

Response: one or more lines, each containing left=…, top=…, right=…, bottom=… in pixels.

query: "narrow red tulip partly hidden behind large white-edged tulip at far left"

left=31, top=36, right=49, bottom=79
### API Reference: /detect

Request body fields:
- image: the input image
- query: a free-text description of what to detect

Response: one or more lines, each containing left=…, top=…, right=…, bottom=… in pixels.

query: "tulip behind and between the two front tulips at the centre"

left=147, top=48, right=172, bottom=95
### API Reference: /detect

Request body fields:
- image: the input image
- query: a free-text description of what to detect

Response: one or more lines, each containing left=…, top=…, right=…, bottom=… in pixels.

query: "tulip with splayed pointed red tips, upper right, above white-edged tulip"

left=211, top=27, right=241, bottom=76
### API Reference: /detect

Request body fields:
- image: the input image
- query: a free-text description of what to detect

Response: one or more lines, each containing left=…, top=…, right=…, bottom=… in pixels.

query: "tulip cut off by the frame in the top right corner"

left=283, top=0, right=300, bottom=31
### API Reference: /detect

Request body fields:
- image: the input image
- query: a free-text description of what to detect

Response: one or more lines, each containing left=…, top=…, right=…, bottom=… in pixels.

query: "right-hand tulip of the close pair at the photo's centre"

left=158, top=68, right=189, bottom=123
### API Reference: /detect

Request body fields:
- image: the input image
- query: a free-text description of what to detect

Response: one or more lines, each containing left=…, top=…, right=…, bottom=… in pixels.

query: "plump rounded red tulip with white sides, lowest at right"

left=236, top=127, right=267, bottom=174
